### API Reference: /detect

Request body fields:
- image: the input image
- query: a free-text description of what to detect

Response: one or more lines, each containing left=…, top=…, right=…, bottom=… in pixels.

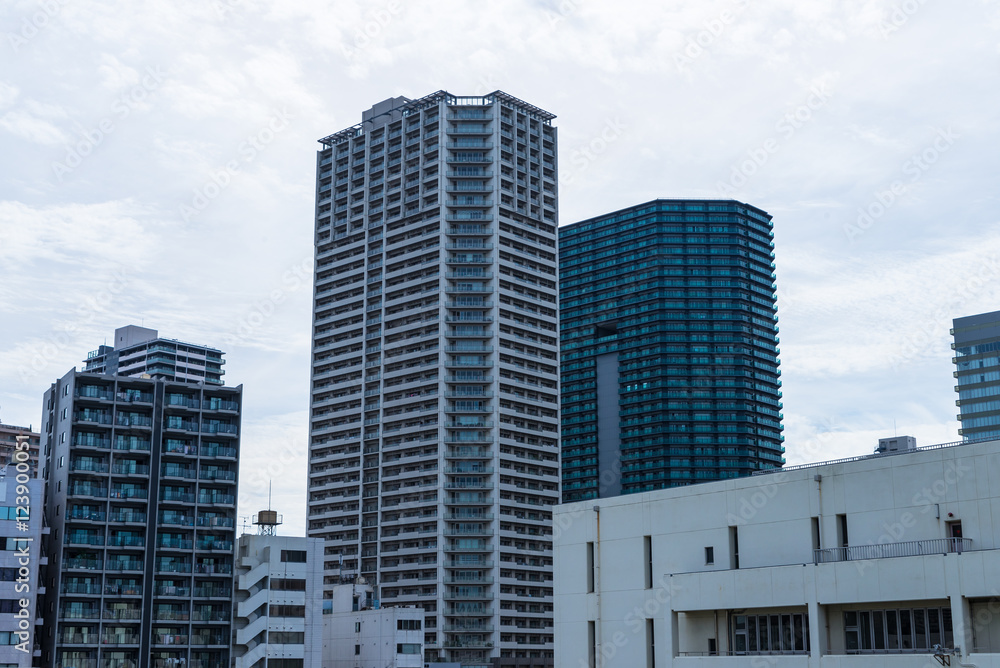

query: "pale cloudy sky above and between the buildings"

left=0, top=0, right=1000, bottom=532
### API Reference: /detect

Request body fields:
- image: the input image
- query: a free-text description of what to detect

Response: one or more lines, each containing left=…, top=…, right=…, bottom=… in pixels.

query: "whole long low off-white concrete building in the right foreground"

left=554, top=441, right=1000, bottom=668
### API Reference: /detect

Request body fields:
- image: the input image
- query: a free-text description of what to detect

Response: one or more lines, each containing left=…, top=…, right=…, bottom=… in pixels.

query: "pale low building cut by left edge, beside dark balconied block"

left=0, top=454, right=48, bottom=668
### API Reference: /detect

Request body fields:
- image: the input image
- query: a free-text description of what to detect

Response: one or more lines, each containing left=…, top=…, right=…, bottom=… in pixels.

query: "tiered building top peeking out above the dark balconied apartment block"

left=84, top=325, right=226, bottom=385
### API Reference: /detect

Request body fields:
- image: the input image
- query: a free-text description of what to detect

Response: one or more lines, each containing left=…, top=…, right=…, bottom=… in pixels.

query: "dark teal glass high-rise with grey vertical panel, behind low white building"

left=559, top=199, right=785, bottom=502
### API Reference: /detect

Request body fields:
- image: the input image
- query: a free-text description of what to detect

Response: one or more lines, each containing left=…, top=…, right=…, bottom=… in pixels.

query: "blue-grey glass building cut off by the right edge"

left=951, top=311, right=1000, bottom=441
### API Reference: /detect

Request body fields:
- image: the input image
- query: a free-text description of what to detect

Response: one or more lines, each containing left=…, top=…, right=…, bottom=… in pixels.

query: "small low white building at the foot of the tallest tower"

left=323, top=584, right=424, bottom=668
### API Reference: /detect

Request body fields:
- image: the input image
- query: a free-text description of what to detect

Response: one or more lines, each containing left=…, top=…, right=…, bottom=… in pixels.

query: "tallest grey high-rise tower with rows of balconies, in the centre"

left=308, top=91, right=559, bottom=666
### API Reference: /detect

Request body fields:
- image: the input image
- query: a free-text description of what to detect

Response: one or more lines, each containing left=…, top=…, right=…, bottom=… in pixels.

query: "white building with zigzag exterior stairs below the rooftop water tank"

left=233, top=534, right=323, bottom=668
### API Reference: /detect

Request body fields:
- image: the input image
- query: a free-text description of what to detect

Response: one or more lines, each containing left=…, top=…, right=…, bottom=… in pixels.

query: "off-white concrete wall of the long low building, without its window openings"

left=554, top=442, right=1000, bottom=668
